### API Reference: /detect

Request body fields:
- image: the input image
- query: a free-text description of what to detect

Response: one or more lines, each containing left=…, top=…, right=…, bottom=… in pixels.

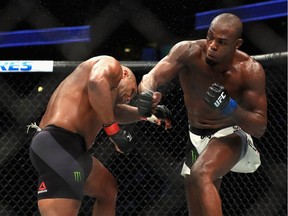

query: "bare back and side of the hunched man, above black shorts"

left=40, top=56, right=117, bottom=148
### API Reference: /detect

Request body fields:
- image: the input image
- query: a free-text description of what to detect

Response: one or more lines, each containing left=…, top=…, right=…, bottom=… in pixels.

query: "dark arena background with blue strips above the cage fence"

left=0, top=0, right=287, bottom=61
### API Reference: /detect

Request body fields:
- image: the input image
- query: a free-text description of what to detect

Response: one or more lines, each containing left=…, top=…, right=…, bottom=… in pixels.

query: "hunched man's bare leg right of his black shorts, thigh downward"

left=84, top=158, right=118, bottom=216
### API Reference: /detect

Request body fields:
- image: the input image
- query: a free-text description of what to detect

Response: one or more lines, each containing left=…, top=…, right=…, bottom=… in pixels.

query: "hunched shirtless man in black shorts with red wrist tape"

left=30, top=56, right=171, bottom=216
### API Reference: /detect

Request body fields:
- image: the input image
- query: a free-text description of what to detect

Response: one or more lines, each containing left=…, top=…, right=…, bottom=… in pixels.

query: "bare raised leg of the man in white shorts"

left=185, top=134, right=242, bottom=216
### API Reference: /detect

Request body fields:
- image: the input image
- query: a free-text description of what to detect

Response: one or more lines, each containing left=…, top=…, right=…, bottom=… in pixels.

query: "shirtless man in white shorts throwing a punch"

left=138, top=13, right=267, bottom=216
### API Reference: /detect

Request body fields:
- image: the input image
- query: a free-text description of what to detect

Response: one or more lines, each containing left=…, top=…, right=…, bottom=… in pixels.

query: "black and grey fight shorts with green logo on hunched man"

left=29, top=125, right=92, bottom=200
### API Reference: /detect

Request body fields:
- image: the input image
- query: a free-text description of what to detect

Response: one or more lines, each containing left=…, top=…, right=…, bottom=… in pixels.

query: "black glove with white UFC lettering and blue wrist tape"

left=204, top=83, right=237, bottom=115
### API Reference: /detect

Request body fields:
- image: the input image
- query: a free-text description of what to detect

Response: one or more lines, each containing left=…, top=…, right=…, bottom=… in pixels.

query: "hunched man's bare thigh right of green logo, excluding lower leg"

left=84, top=157, right=117, bottom=198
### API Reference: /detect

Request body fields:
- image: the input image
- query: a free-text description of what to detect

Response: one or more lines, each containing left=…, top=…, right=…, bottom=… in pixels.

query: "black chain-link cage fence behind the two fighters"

left=0, top=57, right=287, bottom=216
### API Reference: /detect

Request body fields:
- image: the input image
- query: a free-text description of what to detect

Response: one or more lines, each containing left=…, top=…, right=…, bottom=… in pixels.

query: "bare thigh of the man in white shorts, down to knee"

left=192, top=134, right=242, bottom=179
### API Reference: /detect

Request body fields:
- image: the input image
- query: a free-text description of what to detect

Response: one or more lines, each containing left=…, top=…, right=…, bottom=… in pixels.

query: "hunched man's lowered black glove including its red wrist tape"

left=104, top=122, right=132, bottom=153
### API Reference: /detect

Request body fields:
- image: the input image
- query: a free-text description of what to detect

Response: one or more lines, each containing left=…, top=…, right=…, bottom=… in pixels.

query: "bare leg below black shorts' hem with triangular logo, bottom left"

left=38, top=198, right=81, bottom=216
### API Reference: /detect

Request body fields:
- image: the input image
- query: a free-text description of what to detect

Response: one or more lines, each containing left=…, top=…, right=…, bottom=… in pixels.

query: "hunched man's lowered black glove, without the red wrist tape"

left=109, top=130, right=133, bottom=153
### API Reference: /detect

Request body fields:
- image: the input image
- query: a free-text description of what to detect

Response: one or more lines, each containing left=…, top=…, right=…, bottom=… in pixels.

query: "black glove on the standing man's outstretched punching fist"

left=137, top=90, right=153, bottom=117
